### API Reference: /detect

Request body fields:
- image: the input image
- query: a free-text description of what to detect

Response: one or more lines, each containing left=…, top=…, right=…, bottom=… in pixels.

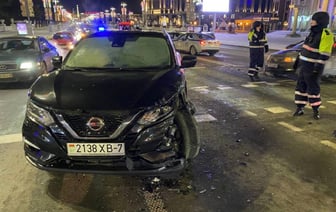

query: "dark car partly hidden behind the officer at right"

left=265, top=41, right=336, bottom=77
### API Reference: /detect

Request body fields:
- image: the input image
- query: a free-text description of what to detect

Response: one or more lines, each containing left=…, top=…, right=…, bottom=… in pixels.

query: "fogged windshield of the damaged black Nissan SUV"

left=65, top=34, right=172, bottom=69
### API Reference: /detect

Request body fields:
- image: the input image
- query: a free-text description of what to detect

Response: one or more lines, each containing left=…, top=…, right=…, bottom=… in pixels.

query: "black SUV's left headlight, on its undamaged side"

left=26, top=101, right=54, bottom=126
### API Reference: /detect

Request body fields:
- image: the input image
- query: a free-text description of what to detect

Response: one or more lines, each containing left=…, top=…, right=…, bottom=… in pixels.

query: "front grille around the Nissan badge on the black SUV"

left=55, top=111, right=129, bottom=137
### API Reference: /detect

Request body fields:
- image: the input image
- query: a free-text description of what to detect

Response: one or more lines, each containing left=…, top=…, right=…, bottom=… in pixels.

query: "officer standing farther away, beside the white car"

left=247, top=21, right=268, bottom=82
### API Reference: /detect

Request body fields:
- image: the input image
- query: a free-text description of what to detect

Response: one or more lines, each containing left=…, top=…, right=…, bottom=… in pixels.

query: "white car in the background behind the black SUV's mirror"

left=173, top=32, right=221, bottom=56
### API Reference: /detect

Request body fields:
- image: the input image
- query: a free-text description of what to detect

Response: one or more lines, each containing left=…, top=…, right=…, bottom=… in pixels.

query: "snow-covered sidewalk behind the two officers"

left=215, top=30, right=307, bottom=50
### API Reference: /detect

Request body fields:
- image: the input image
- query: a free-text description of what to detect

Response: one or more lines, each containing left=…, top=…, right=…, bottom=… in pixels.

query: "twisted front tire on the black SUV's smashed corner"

left=175, top=110, right=201, bottom=161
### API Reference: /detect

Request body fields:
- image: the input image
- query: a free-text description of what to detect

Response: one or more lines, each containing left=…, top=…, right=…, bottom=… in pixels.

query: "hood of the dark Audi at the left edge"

left=0, top=50, right=38, bottom=62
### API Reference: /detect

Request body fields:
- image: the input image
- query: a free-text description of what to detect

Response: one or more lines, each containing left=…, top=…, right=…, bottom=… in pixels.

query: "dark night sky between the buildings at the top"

left=59, top=0, right=141, bottom=14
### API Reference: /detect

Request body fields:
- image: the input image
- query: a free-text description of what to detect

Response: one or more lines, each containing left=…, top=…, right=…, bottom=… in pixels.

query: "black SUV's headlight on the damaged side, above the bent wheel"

left=138, top=105, right=173, bottom=125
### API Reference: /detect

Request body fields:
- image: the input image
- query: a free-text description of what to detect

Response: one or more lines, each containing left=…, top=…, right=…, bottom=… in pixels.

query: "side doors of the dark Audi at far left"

left=38, top=37, right=59, bottom=71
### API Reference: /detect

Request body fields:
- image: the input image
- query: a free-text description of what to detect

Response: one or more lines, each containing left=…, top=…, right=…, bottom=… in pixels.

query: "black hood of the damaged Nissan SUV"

left=30, top=70, right=184, bottom=110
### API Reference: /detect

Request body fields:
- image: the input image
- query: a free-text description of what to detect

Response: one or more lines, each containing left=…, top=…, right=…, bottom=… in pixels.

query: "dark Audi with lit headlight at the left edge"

left=0, top=36, right=58, bottom=83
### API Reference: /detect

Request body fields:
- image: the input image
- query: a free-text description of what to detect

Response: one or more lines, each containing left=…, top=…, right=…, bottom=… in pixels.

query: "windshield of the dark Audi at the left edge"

left=0, top=38, right=37, bottom=50
